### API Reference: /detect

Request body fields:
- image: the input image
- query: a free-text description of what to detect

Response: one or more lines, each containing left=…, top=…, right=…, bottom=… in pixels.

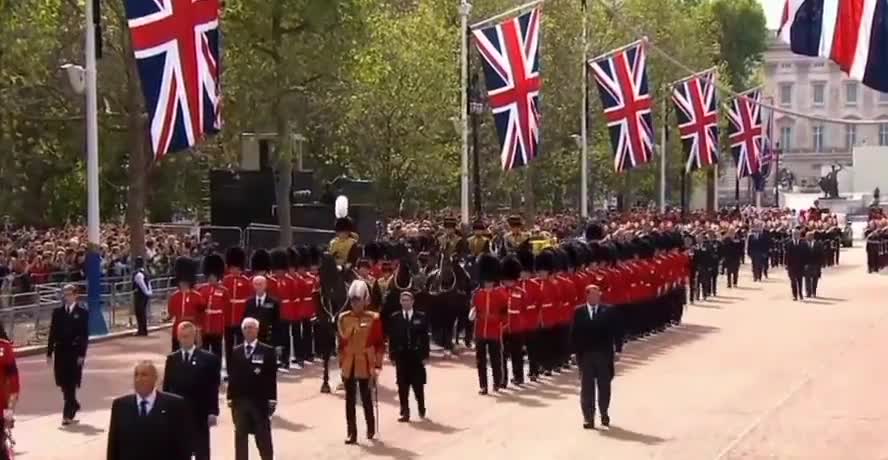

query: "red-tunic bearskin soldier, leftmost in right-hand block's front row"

left=469, top=254, right=509, bottom=395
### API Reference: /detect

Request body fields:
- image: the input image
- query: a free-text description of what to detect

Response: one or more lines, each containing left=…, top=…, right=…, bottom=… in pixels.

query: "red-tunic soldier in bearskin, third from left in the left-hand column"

left=222, top=246, right=253, bottom=372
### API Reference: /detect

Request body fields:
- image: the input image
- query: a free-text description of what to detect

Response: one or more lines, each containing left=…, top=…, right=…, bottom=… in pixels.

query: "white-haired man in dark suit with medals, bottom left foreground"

left=227, top=316, right=277, bottom=460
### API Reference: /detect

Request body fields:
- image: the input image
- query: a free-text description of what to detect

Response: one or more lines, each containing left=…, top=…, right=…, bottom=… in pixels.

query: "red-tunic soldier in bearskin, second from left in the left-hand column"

left=197, top=254, right=231, bottom=362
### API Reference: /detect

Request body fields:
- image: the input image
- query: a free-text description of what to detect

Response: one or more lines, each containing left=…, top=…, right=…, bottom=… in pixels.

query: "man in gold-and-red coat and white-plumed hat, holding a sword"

left=337, top=280, right=385, bottom=444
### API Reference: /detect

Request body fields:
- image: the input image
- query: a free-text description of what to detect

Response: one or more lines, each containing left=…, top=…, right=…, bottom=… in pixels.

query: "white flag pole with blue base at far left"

left=85, top=0, right=108, bottom=335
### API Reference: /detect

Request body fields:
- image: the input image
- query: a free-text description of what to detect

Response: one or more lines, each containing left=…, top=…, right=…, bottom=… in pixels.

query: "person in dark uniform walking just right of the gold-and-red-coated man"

left=388, top=291, right=429, bottom=422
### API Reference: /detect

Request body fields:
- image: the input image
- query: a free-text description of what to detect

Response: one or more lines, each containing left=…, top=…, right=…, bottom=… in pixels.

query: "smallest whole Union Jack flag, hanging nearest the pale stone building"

left=728, top=90, right=762, bottom=177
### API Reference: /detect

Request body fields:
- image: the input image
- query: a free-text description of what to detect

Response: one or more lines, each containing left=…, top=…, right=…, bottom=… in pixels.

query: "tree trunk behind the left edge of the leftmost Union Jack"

left=120, top=12, right=153, bottom=258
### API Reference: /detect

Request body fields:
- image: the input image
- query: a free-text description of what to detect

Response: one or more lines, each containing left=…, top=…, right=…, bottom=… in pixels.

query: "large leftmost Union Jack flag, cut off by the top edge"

left=125, top=0, right=222, bottom=160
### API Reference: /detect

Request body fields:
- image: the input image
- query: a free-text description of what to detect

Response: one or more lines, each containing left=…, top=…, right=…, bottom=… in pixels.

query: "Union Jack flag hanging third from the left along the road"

left=589, top=42, right=654, bottom=172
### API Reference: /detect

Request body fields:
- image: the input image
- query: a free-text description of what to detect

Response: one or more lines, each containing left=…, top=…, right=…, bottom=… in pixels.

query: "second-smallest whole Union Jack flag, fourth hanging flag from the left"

left=672, top=72, right=718, bottom=172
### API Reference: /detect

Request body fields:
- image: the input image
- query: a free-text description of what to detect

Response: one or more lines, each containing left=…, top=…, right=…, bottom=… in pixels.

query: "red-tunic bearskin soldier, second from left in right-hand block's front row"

left=501, top=256, right=527, bottom=388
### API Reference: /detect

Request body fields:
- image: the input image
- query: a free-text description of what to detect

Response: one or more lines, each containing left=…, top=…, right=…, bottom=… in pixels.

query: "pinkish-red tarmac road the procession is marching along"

left=15, top=248, right=888, bottom=460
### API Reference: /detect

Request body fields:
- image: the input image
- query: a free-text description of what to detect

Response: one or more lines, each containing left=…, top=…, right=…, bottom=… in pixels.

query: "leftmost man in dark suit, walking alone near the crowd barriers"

left=46, top=284, right=89, bottom=426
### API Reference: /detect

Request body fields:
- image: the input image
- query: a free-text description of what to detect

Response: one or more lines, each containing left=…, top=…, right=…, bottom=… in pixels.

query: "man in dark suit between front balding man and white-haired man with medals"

left=163, top=321, right=222, bottom=460
